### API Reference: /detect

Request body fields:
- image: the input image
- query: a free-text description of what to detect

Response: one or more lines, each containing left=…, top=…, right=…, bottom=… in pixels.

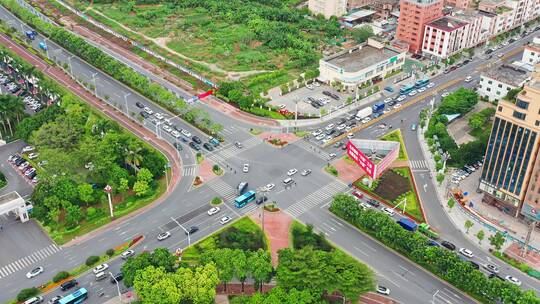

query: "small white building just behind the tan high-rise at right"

left=477, top=64, right=531, bottom=101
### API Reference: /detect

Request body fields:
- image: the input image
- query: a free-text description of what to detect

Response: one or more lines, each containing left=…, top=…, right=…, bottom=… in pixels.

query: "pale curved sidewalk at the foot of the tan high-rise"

left=418, top=124, right=540, bottom=251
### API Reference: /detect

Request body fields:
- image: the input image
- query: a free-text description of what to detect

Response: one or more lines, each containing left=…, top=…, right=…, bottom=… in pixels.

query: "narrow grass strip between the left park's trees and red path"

left=47, top=177, right=167, bottom=245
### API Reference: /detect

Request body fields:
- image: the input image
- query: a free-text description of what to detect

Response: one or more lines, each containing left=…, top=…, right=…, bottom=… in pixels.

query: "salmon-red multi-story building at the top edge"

left=396, top=0, right=443, bottom=53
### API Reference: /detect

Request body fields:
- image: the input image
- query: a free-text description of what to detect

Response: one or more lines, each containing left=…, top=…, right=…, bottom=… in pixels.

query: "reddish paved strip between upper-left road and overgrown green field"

left=70, top=25, right=279, bottom=126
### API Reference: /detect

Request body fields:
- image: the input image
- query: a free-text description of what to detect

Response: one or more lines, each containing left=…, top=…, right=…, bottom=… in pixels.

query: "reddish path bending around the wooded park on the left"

left=0, top=34, right=182, bottom=247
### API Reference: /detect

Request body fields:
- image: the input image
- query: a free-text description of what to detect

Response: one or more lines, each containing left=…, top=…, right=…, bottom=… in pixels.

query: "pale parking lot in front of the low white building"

left=269, top=84, right=354, bottom=117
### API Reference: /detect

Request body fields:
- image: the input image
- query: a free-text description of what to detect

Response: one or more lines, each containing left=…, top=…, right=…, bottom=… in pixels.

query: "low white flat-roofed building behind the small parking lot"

left=319, top=38, right=406, bottom=90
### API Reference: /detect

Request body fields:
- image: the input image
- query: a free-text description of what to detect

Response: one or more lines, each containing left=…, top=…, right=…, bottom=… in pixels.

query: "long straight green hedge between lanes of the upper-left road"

left=0, top=0, right=223, bottom=135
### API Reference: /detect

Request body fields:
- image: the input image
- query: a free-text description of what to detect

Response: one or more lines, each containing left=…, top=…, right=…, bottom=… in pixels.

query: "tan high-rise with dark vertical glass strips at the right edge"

left=479, top=68, right=540, bottom=217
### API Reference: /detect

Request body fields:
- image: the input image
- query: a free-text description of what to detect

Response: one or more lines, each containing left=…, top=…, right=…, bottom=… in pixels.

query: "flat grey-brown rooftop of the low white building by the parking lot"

left=323, top=39, right=401, bottom=73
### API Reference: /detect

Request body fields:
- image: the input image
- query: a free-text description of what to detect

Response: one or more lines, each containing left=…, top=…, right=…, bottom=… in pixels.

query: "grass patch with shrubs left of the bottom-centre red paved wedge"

left=182, top=216, right=268, bottom=265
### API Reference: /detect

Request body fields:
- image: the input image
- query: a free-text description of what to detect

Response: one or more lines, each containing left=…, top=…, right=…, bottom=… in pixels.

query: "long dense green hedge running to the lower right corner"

left=330, top=194, right=540, bottom=304
